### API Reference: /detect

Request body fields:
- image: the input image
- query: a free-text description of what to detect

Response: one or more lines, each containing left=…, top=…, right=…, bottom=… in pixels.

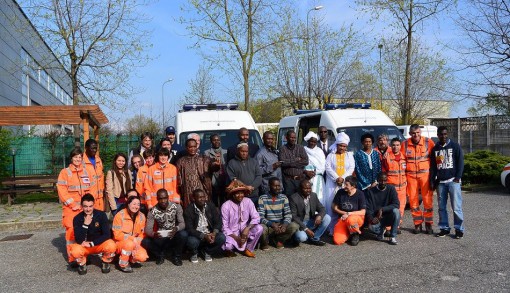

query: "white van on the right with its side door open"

left=278, top=103, right=404, bottom=151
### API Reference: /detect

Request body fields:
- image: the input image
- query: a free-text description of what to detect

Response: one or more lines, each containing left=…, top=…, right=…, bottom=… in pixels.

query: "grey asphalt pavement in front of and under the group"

left=0, top=191, right=510, bottom=292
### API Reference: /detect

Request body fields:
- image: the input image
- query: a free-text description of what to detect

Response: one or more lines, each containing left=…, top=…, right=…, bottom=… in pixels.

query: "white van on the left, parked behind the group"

left=174, top=104, right=262, bottom=153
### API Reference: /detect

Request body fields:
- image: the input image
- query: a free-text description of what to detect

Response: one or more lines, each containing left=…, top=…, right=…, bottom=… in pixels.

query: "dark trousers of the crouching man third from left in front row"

left=142, top=230, right=188, bottom=258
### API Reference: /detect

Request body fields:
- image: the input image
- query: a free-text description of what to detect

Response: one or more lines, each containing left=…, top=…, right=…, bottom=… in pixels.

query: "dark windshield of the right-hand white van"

left=336, top=126, right=404, bottom=152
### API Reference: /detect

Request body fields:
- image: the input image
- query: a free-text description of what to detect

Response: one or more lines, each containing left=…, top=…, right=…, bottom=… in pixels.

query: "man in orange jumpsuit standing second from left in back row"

left=83, top=138, right=105, bottom=211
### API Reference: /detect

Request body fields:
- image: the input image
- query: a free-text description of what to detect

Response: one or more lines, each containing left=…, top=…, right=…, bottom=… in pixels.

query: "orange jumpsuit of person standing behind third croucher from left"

left=144, top=162, right=181, bottom=209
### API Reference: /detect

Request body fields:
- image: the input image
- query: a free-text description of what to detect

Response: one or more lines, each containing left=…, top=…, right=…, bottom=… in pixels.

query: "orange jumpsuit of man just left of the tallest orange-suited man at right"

left=382, top=151, right=407, bottom=224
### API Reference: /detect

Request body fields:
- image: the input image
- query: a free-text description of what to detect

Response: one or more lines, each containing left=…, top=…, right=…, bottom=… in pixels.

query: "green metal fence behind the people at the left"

left=2, top=135, right=139, bottom=176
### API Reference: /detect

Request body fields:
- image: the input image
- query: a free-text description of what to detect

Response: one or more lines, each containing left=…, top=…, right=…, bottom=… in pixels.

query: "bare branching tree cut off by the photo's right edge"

left=457, top=0, right=510, bottom=115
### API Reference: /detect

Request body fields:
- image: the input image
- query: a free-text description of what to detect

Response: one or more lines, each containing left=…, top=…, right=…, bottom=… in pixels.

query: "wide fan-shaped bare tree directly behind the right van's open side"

left=264, top=13, right=374, bottom=109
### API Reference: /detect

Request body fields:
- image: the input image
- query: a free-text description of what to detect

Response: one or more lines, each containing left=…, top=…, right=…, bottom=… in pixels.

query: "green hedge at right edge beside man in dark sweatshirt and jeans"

left=462, top=151, right=510, bottom=184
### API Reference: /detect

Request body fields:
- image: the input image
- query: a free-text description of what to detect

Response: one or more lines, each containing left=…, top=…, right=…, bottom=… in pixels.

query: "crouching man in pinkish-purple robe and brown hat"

left=221, top=179, right=262, bottom=257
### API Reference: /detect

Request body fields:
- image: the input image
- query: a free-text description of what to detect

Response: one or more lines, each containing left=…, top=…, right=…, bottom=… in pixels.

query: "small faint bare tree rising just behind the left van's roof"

left=183, top=65, right=216, bottom=104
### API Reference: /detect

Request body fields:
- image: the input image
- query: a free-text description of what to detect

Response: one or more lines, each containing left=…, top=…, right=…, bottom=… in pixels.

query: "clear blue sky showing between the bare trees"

left=104, top=0, right=469, bottom=128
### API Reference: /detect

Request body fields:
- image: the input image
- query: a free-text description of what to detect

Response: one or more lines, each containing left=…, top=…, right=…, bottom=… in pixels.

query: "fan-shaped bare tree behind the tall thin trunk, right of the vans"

left=382, top=39, right=455, bottom=124
